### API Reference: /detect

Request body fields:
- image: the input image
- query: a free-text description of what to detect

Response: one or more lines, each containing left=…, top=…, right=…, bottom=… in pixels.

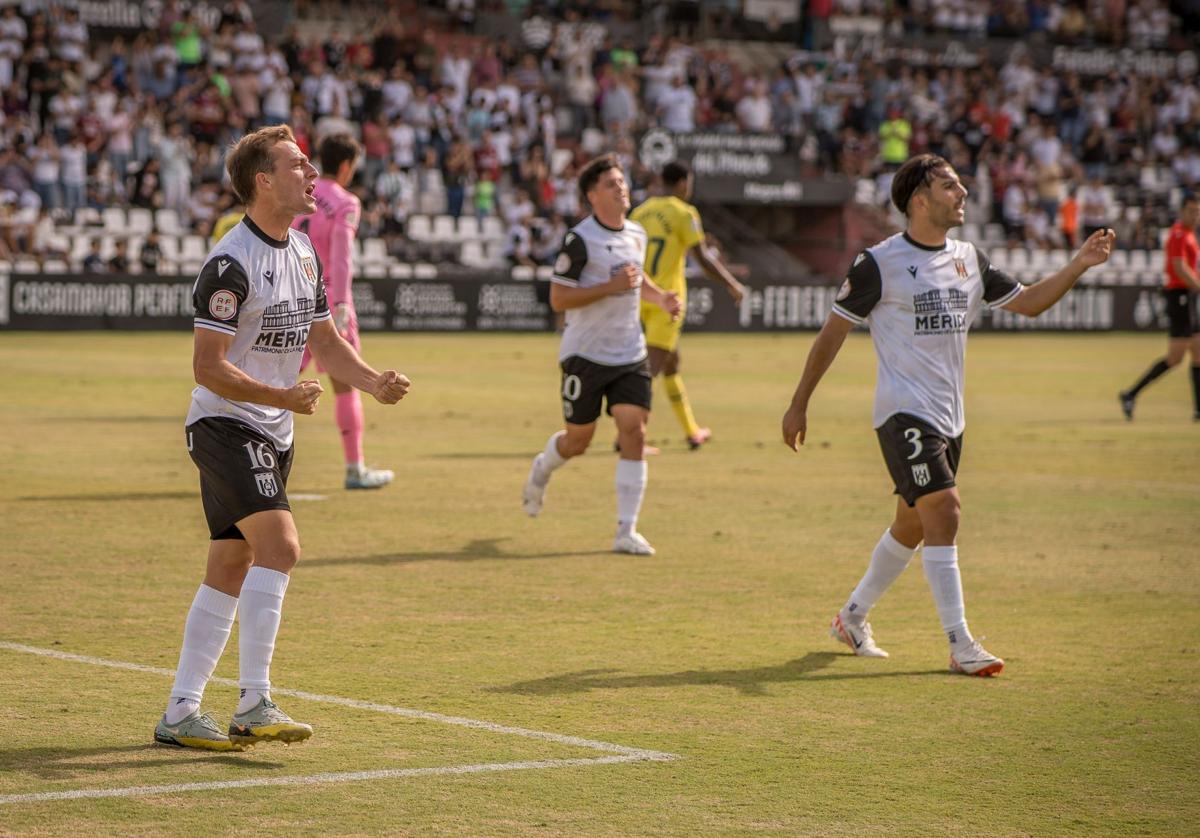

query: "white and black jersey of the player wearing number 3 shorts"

left=833, top=233, right=1021, bottom=437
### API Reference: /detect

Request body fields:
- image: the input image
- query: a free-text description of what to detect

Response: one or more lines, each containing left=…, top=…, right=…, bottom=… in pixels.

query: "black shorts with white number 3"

left=875, top=413, right=962, bottom=507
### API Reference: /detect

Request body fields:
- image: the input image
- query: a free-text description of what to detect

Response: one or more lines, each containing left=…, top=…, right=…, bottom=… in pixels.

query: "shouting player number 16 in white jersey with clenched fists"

left=155, top=125, right=409, bottom=750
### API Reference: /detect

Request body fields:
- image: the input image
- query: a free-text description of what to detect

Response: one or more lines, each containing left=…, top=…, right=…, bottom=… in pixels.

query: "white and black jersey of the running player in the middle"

left=553, top=215, right=646, bottom=365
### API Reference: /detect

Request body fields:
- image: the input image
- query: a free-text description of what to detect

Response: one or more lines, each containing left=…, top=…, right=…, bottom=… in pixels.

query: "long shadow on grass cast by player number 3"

left=487, top=652, right=946, bottom=695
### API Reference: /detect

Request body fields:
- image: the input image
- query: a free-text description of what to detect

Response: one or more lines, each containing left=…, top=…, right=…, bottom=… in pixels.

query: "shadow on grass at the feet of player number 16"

left=0, top=742, right=286, bottom=780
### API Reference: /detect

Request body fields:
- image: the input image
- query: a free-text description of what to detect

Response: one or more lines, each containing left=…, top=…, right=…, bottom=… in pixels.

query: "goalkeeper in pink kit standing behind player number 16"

left=292, top=134, right=395, bottom=489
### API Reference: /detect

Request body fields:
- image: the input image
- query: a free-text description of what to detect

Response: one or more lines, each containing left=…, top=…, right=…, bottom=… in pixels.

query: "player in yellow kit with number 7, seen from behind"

left=629, top=162, right=745, bottom=450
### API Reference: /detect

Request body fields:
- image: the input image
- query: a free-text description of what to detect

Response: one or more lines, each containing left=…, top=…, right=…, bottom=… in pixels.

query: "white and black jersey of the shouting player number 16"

left=187, top=216, right=330, bottom=451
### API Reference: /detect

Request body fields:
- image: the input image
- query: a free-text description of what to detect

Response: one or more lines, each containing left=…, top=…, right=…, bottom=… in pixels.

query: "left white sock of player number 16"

left=167, top=585, right=238, bottom=724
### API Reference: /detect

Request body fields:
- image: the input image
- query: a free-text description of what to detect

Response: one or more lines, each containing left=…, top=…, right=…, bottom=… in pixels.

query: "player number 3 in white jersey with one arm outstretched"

left=782, top=154, right=1115, bottom=676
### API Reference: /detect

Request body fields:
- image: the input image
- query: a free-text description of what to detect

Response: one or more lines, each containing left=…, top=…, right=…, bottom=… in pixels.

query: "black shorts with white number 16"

left=185, top=418, right=295, bottom=541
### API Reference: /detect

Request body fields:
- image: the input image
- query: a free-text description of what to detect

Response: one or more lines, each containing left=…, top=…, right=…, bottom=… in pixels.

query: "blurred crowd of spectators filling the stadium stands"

left=0, top=0, right=1200, bottom=271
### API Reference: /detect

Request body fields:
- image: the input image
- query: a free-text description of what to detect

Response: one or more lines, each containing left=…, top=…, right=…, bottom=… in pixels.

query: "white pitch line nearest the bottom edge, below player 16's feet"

left=0, top=755, right=646, bottom=806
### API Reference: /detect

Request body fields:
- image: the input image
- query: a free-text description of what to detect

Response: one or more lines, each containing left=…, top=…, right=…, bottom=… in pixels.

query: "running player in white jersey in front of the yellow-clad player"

left=522, top=155, right=680, bottom=556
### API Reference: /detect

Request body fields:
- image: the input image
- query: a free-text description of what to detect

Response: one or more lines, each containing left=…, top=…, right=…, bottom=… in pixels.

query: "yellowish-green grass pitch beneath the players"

left=0, top=334, right=1200, bottom=836
